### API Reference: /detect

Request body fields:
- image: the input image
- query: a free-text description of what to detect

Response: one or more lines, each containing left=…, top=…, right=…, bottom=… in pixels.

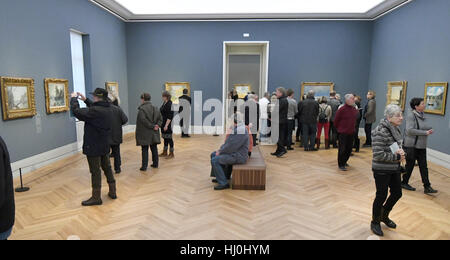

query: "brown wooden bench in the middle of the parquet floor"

left=231, top=146, right=267, bottom=190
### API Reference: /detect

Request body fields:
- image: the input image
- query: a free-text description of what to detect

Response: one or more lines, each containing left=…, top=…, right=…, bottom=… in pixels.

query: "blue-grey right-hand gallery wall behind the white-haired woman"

left=369, top=0, right=450, bottom=154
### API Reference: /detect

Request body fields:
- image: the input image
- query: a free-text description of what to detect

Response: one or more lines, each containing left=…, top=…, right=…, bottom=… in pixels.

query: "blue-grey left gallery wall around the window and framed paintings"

left=0, top=0, right=128, bottom=161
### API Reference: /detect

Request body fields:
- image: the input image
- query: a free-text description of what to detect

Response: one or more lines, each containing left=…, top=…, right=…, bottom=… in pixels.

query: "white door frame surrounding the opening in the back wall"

left=221, top=41, right=270, bottom=133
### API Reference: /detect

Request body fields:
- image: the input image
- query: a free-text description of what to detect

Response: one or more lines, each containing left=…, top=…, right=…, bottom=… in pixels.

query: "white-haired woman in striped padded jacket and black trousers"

left=371, top=105, right=405, bottom=236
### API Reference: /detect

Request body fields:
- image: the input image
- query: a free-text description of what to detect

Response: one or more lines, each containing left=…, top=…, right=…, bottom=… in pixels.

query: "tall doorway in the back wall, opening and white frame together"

left=220, top=41, right=269, bottom=131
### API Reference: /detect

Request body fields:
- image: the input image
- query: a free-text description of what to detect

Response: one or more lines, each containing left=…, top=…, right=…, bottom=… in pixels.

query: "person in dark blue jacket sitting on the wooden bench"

left=211, top=114, right=250, bottom=190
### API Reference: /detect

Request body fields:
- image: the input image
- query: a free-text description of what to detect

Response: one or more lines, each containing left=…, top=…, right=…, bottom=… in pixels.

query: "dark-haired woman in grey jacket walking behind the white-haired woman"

left=402, top=98, right=438, bottom=194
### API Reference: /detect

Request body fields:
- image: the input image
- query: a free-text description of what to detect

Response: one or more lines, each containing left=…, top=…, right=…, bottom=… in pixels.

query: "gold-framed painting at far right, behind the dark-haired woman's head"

left=424, top=82, right=448, bottom=116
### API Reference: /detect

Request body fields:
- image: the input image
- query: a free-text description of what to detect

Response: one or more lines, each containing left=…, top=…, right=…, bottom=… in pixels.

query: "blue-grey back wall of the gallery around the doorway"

left=127, top=21, right=372, bottom=123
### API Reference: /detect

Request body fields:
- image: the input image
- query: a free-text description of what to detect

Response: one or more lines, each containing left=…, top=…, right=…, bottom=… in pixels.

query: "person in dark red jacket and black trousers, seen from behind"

left=334, top=94, right=358, bottom=171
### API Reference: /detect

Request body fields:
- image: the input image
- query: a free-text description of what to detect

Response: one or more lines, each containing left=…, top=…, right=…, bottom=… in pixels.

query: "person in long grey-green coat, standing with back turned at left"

left=136, top=93, right=163, bottom=171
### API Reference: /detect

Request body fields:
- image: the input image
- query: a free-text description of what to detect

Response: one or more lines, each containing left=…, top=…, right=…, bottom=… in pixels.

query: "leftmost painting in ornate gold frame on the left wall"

left=0, top=77, right=36, bottom=121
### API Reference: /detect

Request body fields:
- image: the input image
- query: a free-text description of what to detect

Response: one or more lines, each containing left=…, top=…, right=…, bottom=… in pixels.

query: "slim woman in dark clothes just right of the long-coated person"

left=159, top=91, right=175, bottom=159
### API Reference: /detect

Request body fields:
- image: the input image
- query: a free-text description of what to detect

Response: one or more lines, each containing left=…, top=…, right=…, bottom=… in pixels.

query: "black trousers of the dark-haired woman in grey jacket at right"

left=402, top=147, right=431, bottom=188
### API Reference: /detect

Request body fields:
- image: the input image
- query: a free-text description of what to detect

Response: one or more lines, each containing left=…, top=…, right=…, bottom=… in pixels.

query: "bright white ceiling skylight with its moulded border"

left=90, top=0, right=412, bottom=22
